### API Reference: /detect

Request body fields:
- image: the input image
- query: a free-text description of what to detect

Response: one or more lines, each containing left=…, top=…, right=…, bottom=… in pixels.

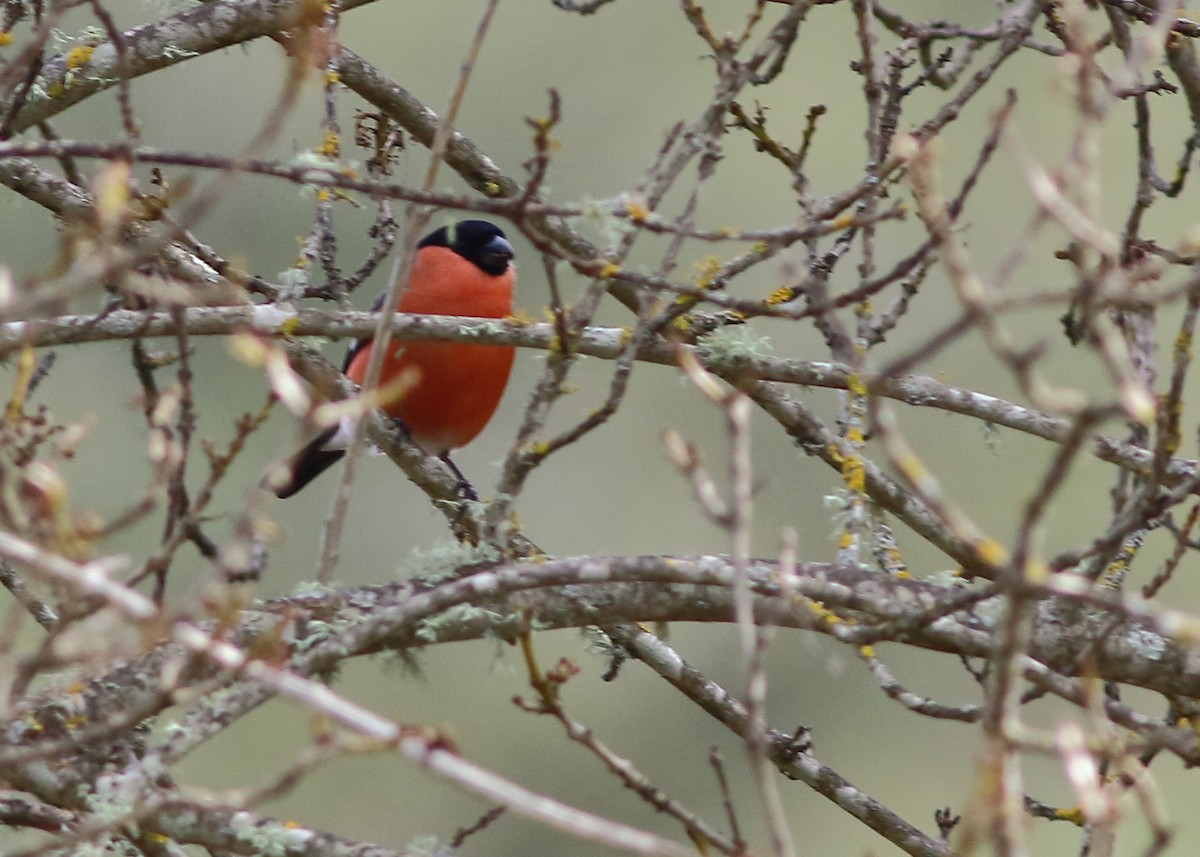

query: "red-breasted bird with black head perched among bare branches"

left=270, top=220, right=516, bottom=499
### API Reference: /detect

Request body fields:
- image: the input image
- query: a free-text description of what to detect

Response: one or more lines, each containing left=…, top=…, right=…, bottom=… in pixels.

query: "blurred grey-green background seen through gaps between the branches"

left=0, top=0, right=1200, bottom=857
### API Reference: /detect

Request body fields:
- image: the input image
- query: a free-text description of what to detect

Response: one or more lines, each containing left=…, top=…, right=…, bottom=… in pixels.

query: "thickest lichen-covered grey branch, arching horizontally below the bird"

left=7, top=556, right=1200, bottom=761
